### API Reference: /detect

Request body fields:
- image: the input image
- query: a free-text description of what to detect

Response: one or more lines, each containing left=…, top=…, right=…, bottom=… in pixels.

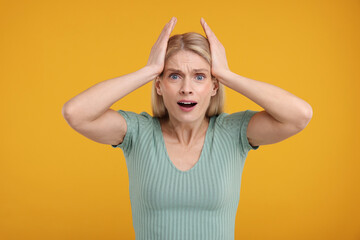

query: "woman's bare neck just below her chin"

left=163, top=116, right=209, bottom=146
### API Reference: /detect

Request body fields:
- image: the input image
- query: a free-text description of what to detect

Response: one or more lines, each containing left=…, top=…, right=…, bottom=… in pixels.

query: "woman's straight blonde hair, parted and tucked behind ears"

left=151, top=32, right=225, bottom=118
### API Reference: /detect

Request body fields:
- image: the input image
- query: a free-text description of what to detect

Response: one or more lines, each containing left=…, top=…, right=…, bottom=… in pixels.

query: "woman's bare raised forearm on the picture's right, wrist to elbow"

left=218, top=71, right=312, bottom=126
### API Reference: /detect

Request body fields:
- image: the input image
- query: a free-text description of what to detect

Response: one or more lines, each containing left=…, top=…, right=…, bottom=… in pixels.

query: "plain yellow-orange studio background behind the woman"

left=0, top=0, right=360, bottom=240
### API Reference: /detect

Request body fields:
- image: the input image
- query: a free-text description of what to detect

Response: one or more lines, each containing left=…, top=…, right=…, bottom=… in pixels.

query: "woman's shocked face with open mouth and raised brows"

left=156, top=51, right=218, bottom=122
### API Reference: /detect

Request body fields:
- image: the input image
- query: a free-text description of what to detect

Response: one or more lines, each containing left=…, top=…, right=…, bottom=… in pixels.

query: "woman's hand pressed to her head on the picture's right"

left=200, top=18, right=230, bottom=81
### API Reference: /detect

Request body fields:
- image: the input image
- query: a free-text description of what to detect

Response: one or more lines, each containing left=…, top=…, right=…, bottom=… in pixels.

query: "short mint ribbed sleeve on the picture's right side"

left=221, top=110, right=259, bottom=153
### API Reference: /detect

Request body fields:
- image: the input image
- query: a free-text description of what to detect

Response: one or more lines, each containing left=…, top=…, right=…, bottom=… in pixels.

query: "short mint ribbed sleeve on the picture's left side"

left=111, top=110, right=152, bottom=152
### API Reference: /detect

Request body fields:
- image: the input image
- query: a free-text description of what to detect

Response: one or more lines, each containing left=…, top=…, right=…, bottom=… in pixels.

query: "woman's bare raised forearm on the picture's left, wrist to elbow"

left=63, top=66, right=157, bottom=121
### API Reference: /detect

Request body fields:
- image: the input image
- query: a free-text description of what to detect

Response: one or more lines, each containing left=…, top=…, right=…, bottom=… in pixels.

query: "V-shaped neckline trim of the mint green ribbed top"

left=156, top=117, right=213, bottom=174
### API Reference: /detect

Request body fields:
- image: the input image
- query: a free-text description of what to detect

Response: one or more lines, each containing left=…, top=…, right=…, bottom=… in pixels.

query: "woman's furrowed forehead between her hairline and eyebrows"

left=164, top=51, right=210, bottom=71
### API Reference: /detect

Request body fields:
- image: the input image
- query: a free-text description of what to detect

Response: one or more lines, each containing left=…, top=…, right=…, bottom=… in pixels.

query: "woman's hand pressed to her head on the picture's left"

left=146, top=17, right=177, bottom=75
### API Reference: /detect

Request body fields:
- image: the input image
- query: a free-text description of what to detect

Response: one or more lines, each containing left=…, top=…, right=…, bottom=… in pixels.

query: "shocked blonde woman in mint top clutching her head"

left=63, top=18, right=312, bottom=240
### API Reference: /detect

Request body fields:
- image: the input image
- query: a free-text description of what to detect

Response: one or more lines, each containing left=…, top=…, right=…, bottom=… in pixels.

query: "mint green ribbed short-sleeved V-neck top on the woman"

left=111, top=110, right=259, bottom=240
